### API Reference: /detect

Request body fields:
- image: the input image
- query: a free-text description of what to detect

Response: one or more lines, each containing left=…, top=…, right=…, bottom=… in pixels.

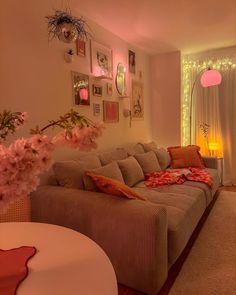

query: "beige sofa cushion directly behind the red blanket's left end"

left=134, top=151, right=161, bottom=174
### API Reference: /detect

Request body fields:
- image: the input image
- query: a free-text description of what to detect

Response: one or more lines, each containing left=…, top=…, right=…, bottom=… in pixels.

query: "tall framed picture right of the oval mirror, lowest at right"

left=131, top=80, right=144, bottom=119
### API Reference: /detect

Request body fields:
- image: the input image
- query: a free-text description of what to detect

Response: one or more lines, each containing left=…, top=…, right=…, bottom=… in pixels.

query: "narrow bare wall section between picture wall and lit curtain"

left=151, top=51, right=181, bottom=147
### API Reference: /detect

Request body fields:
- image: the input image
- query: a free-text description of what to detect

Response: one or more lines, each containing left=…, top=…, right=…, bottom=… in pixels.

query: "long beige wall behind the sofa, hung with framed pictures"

left=0, top=0, right=151, bottom=158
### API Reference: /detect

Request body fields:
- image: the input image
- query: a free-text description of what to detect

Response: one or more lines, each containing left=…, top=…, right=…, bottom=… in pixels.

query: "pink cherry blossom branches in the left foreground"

left=0, top=110, right=104, bottom=212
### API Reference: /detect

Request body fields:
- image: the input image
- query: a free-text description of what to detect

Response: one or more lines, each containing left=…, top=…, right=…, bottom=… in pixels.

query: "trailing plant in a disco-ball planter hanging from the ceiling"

left=46, top=10, right=89, bottom=43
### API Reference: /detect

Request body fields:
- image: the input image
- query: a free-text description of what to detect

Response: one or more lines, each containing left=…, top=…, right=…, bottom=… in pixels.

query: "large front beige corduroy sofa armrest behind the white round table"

left=31, top=186, right=168, bottom=294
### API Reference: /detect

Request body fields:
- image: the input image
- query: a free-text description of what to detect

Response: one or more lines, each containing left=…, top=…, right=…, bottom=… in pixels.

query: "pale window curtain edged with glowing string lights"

left=182, top=58, right=236, bottom=185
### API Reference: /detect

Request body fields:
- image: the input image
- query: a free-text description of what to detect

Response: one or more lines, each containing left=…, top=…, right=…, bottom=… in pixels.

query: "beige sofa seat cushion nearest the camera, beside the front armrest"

left=134, top=183, right=206, bottom=267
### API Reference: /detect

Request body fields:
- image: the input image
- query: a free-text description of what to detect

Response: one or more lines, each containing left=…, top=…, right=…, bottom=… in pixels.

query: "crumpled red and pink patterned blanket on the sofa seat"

left=145, top=167, right=213, bottom=188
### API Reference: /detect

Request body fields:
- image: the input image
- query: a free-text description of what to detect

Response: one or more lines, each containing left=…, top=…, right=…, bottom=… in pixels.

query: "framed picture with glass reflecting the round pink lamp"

left=71, top=72, right=90, bottom=106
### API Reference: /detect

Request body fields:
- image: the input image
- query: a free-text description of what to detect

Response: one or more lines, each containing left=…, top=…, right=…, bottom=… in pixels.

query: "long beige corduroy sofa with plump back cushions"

left=31, top=143, right=220, bottom=294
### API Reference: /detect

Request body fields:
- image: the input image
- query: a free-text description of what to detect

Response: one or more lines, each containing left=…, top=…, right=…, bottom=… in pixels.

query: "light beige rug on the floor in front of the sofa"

left=169, top=191, right=236, bottom=295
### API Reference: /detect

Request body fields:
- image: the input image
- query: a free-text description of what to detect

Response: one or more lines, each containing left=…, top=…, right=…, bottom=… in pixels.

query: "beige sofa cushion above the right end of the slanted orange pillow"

left=117, top=156, right=144, bottom=186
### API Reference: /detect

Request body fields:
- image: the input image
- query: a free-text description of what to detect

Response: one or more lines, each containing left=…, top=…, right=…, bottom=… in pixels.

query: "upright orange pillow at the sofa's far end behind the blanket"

left=167, top=145, right=205, bottom=168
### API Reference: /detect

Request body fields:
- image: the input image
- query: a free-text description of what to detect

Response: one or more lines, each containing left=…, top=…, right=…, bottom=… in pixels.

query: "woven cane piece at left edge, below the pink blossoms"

left=0, top=197, right=31, bottom=222
